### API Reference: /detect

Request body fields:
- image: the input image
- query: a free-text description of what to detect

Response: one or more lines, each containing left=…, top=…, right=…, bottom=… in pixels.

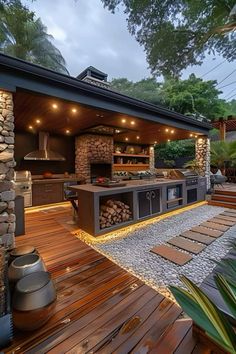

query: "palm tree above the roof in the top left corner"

left=0, top=0, right=69, bottom=74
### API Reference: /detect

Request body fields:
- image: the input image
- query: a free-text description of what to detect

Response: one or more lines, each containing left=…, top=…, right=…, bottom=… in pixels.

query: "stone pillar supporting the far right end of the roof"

left=195, top=136, right=210, bottom=189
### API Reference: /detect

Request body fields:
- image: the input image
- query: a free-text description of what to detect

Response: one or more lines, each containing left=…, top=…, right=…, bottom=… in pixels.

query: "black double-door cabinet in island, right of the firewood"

left=138, top=189, right=160, bottom=219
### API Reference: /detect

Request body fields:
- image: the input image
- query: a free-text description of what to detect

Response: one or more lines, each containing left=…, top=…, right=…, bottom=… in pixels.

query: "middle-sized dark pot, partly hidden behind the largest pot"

left=8, top=254, right=46, bottom=284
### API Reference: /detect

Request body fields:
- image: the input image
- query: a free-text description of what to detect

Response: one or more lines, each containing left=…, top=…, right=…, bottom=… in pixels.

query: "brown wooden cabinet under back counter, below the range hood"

left=32, top=182, right=64, bottom=206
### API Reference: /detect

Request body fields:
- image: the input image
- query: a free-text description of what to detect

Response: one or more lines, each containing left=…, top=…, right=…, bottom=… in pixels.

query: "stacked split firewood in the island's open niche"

left=99, top=199, right=132, bottom=229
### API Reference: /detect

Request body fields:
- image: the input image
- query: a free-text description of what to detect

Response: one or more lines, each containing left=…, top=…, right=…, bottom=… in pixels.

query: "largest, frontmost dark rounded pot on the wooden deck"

left=13, top=272, right=56, bottom=331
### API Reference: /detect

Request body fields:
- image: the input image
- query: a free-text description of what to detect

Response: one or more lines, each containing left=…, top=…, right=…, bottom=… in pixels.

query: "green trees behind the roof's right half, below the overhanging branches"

left=111, top=74, right=236, bottom=120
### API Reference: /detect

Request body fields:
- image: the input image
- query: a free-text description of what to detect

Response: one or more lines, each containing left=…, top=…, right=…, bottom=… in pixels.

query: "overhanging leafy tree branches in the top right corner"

left=102, top=0, right=236, bottom=77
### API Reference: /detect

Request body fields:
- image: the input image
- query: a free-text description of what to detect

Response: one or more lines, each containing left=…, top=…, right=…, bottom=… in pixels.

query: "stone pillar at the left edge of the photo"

left=0, top=91, right=15, bottom=247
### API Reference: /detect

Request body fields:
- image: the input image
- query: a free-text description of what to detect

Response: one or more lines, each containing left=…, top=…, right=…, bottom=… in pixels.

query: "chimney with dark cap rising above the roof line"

left=77, top=66, right=110, bottom=89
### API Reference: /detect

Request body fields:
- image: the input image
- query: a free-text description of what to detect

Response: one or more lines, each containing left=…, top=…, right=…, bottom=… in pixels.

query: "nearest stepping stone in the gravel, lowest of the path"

left=151, top=245, right=193, bottom=265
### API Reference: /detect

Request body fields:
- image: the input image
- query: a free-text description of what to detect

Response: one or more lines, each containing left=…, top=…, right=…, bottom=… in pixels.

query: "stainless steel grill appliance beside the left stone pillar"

left=14, top=171, right=32, bottom=207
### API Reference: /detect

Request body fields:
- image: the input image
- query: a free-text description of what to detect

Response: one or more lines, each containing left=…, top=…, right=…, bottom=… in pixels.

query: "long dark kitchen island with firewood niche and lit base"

left=70, top=177, right=206, bottom=236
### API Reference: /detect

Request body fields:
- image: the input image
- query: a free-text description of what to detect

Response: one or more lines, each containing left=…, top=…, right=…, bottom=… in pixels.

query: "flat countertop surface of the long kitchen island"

left=70, top=178, right=185, bottom=194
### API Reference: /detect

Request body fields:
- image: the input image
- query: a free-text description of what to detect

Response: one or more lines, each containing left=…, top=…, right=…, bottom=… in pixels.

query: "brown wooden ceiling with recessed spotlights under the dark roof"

left=14, top=91, right=203, bottom=144
